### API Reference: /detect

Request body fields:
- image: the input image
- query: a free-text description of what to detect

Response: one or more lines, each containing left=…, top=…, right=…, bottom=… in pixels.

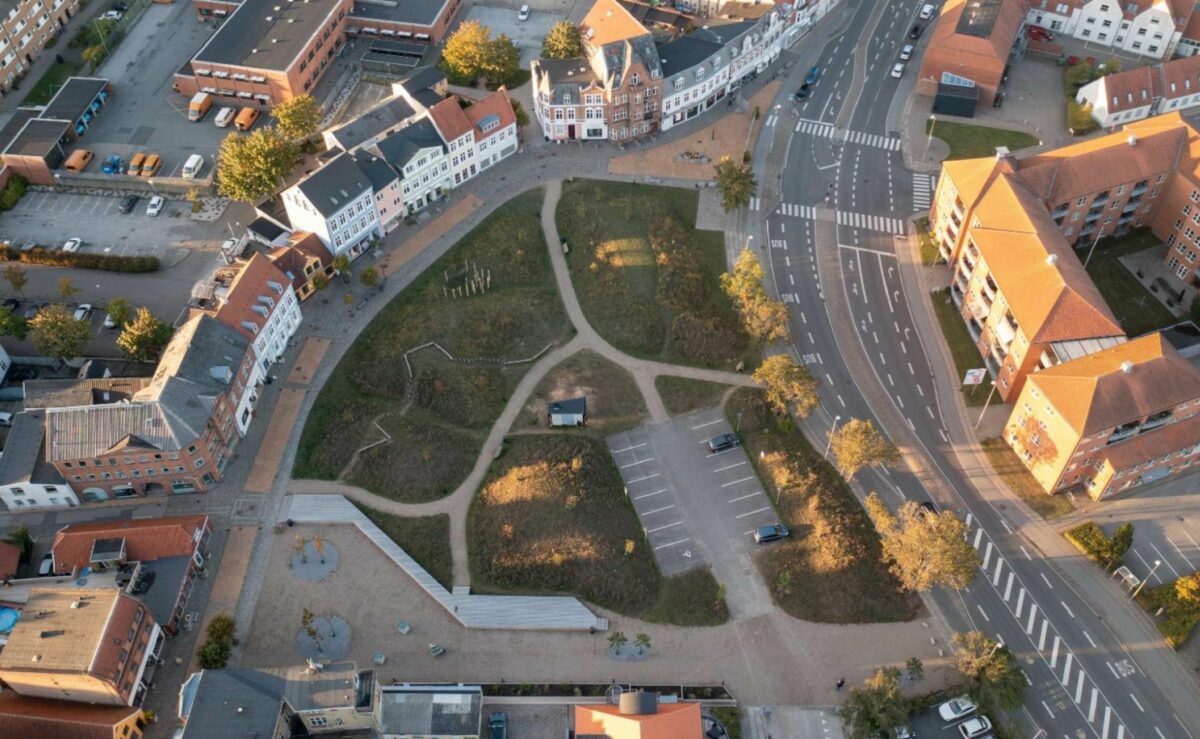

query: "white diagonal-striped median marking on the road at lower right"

left=966, top=513, right=1136, bottom=739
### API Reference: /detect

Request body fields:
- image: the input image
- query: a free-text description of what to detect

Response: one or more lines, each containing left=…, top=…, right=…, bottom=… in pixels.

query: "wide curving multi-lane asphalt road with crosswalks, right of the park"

left=751, top=0, right=1198, bottom=739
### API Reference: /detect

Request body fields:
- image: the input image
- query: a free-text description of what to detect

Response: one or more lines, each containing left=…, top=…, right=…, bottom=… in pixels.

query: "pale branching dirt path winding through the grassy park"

left=288, top=180, right=758, bottom=585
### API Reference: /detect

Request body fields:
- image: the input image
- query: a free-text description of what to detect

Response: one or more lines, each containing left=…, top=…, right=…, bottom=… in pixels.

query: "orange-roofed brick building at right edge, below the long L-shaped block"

left=1004, top=334, right=1200, bottom=500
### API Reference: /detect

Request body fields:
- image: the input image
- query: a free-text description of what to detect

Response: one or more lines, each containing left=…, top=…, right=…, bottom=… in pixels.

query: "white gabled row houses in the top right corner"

left=1028, top=0, right=1194, bottom=59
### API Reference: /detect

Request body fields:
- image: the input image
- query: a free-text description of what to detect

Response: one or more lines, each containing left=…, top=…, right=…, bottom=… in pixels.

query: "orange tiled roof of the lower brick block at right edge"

left=1028, top=334, right=1200, bottom=435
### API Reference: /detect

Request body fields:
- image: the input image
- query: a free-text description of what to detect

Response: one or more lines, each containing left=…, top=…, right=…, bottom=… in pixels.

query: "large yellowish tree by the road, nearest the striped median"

left=866, top=493, right=979, bottom=590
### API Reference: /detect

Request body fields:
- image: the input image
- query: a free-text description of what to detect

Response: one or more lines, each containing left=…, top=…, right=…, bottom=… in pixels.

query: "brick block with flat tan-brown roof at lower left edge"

left=0, top=587, right=163, bottom=705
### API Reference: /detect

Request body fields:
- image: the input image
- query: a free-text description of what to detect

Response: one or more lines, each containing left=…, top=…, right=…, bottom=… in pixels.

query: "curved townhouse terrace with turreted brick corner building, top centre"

left=530, top=0, right=801, bottom=142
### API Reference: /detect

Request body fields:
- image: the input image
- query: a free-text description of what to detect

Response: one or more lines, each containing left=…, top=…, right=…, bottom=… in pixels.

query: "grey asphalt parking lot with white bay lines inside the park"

left=607, top=408, right=779, bottom=609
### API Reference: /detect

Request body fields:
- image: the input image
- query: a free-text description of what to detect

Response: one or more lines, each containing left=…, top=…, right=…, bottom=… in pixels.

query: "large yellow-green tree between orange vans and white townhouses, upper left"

left=217, top=126, right=300, bottom=205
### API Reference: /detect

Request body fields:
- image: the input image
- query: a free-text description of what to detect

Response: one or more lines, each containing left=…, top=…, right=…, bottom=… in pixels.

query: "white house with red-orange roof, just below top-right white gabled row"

left=1075, top=56, right=1200, bottom=128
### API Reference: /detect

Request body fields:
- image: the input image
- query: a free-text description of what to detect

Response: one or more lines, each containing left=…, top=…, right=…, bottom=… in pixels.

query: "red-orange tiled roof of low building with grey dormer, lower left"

left=52, top=515, right=209, bottom=572
